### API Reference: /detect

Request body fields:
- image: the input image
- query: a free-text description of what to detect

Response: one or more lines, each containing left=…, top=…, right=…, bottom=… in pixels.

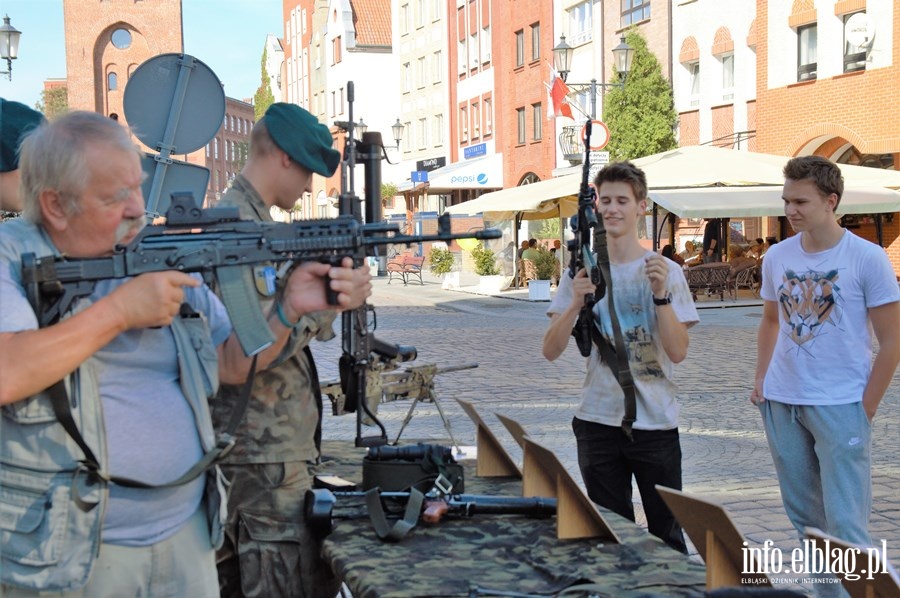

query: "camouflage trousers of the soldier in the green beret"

left=216, top=461, right=341, bottom=598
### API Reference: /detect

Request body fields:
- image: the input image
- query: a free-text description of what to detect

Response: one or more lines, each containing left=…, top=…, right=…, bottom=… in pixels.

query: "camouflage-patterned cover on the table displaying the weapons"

left=320, top=441, right=706, bottom=598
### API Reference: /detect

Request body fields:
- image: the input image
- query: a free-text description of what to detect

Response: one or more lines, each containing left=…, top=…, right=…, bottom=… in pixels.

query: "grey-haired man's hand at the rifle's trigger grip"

left=106, top=270, right=200, bottom=332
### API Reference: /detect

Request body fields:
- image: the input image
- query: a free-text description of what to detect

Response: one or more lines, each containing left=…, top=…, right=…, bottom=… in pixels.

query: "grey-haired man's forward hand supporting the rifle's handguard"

left=282, top=257, right=372, bottom=322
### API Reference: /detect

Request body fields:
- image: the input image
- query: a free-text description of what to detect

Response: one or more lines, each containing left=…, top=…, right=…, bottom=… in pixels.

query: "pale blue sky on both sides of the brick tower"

left=0, top=0, right=284, bottom=106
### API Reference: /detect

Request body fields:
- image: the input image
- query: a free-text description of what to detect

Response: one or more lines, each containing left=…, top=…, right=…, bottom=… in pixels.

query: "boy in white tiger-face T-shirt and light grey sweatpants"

left=750, top=156, right=900, bottom=595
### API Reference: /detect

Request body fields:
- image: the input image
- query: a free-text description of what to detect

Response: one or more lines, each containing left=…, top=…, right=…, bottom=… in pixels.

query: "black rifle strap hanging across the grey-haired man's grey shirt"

left=47, top=356, right=256, bottom=511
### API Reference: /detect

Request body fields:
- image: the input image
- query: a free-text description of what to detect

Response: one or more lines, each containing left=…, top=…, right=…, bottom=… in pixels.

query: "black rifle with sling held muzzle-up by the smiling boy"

left=568, top=120, right=637, bottom=440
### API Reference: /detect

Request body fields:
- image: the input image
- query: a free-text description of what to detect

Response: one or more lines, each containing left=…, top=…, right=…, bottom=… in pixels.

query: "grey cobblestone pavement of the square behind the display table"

left=313, top=275, right=900, bottom=590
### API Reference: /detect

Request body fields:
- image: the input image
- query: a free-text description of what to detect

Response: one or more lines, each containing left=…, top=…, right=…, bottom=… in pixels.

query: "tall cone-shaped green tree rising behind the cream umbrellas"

left=603, top=29, right=678, bottom=161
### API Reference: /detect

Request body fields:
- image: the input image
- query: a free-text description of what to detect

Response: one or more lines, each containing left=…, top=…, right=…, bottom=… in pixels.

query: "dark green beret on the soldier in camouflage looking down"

left=263, top=102, right=341, bottom=176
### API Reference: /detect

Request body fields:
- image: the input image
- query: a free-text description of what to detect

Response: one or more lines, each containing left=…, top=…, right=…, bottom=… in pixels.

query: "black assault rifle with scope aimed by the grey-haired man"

left=22, top=193, right=500, bottom=446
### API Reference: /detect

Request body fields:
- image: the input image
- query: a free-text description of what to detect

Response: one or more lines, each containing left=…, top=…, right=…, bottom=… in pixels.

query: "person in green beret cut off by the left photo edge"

left=0, top=98, right=45, bottom=214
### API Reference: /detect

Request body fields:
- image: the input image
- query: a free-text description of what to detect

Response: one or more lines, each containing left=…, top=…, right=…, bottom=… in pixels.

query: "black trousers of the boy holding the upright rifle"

left=572, top=417, right=687, bottom=554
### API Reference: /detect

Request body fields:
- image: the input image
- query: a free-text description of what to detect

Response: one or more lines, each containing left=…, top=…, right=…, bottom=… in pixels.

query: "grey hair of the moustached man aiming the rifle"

left=19, top=111, right=140, bottom=224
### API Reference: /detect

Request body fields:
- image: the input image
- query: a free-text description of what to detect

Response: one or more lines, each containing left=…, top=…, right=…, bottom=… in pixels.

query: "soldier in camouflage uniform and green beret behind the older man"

left=213, top=103, right=371, bottom=598
